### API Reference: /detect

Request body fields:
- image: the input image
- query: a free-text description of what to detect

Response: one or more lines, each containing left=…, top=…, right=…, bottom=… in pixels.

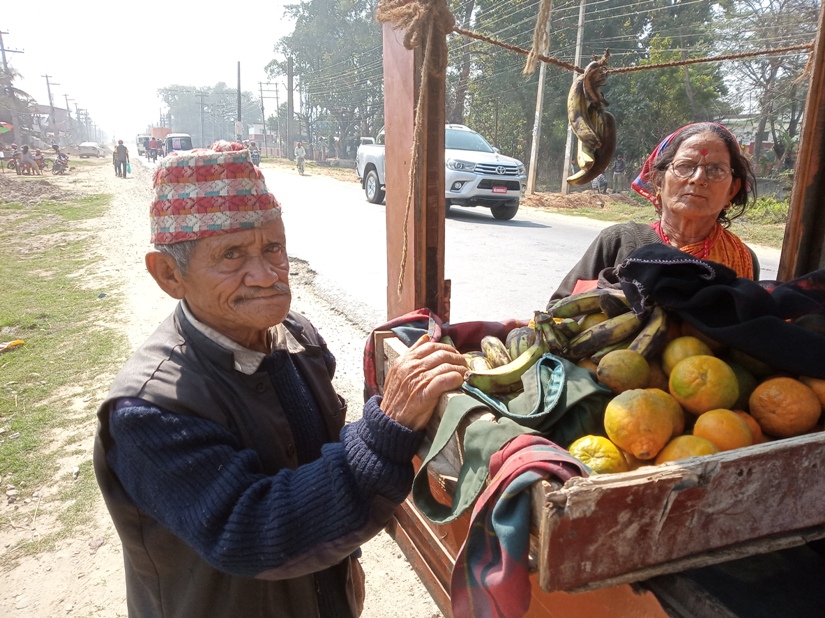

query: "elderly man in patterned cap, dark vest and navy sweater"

left=94, top=142, right=466, bottom=618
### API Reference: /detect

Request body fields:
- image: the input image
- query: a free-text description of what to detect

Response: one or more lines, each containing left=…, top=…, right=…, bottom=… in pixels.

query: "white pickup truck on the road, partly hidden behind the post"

left=355, top=124, right=527, bottom=220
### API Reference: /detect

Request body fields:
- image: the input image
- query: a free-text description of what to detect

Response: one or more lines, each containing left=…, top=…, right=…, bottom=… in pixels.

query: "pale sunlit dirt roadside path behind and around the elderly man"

left=0, top=159, right=441, bottom=618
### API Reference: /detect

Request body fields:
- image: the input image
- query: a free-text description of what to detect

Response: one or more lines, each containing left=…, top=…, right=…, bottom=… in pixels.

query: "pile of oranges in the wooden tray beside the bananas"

left=569, top=324, right=825, bottom=473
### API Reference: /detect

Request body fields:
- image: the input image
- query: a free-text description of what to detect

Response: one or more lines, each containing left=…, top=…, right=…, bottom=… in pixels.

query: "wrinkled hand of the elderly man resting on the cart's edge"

left=381, top=335, right=467, bottom=431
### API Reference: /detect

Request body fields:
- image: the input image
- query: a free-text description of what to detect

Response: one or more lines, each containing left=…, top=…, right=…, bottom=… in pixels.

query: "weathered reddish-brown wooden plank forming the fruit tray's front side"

left=539, top=432, right=825, bottom=591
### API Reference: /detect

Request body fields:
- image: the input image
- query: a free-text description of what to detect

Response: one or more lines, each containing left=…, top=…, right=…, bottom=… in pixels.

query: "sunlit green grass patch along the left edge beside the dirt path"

left=0, top=190, right=128, bottom=555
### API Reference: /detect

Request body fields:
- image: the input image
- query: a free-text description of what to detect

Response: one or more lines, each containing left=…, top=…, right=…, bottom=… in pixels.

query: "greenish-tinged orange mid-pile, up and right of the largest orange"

left=668, top=355, right=739, bottom=415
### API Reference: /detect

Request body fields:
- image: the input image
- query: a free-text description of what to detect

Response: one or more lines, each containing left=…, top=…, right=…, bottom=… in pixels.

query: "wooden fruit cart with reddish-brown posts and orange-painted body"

left=375, top=2, right=825, bottom=618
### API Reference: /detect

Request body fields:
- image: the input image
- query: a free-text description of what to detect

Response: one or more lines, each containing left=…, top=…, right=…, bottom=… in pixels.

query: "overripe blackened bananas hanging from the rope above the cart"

left=567, top=50, right=616, bottom=185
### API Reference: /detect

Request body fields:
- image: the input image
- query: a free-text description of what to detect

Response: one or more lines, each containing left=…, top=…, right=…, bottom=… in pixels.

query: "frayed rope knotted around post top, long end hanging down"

left=375, top=0, right=455, bottom=298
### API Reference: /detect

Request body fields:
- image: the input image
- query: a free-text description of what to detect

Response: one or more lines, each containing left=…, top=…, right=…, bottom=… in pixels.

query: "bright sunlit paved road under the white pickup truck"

left=264, top=162, right=779, bottom=328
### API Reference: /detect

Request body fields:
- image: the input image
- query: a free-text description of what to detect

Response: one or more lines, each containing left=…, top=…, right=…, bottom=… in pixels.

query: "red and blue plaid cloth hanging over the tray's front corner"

left=450, top=435, right=588, bottom=618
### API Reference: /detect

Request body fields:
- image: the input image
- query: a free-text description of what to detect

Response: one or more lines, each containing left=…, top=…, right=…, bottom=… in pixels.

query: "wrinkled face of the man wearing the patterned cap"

left=182, top=219, right=292, bottom=349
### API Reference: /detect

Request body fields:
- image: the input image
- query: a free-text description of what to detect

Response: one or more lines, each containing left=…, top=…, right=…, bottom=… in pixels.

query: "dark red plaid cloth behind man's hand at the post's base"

left=364, top=307, right=527, bottom=399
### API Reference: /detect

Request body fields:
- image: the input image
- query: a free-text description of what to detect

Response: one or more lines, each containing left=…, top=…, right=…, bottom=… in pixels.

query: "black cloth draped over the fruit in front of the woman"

left=616, top=244, right=825, bottom=379
